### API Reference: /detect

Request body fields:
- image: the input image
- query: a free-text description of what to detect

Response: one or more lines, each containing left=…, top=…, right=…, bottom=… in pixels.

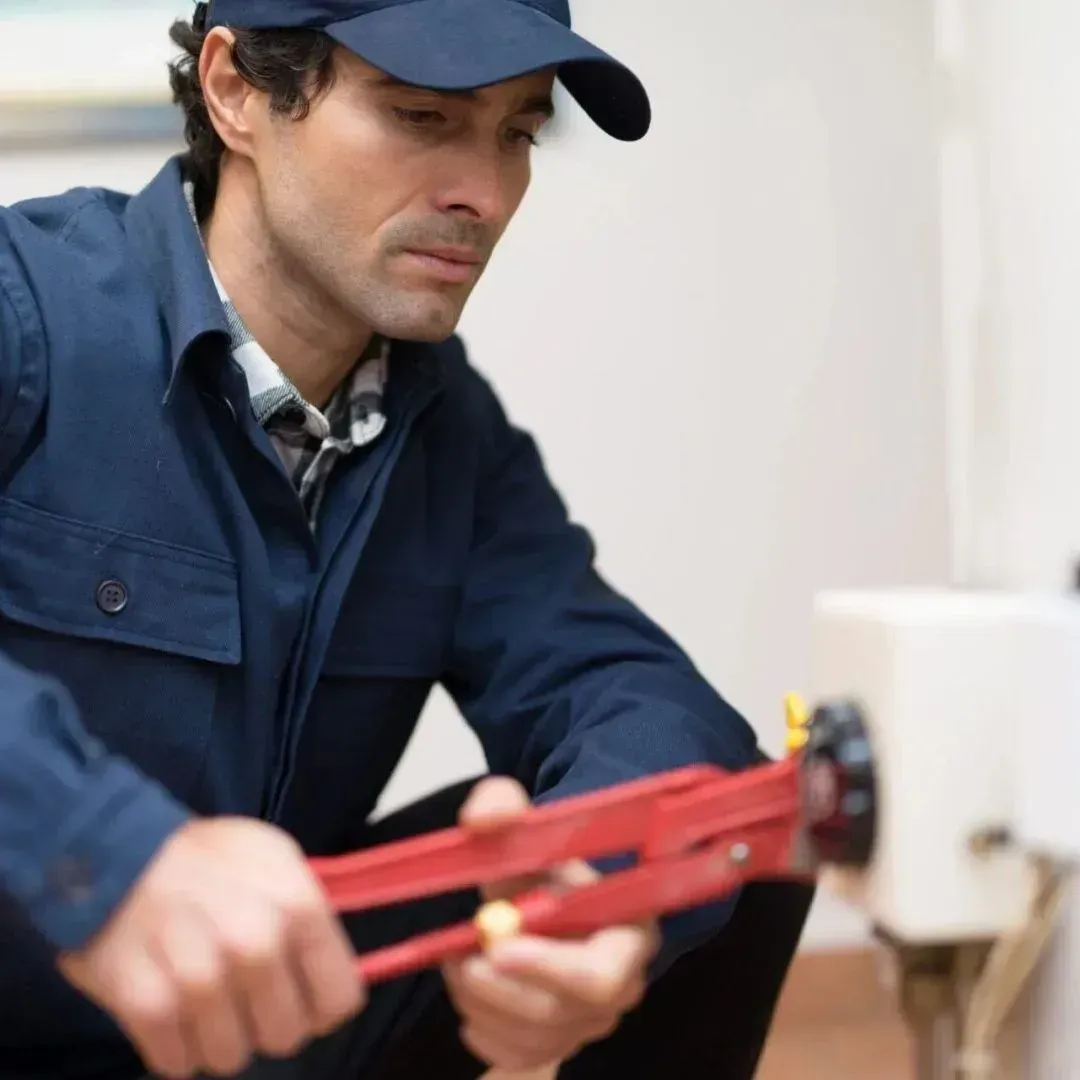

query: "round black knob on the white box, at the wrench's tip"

left=801, top=701, right=878, bottom=868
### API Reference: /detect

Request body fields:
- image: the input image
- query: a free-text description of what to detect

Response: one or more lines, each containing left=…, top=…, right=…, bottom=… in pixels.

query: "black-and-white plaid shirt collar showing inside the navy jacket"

left=185, top=184, right=390, bottom=528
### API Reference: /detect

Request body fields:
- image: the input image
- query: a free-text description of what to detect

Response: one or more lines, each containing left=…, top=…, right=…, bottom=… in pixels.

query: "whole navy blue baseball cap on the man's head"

left=197, top=0, right=651, bottom=141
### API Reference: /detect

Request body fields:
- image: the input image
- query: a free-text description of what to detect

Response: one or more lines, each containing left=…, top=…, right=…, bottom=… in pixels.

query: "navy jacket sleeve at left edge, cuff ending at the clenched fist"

left=0, top=221, right=190, bottom=962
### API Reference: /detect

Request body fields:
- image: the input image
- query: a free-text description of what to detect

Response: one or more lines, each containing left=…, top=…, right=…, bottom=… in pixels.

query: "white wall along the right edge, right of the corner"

left=947, top=0, right=1080, bottom=1080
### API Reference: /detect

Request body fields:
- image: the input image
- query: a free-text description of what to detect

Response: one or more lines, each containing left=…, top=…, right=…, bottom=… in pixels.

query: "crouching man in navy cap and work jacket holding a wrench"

left=0, top=0, right=809, bottom=1080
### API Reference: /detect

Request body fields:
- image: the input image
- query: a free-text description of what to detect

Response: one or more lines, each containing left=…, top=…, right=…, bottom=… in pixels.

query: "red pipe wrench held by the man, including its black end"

left=311, top=698, right=874, bottom=984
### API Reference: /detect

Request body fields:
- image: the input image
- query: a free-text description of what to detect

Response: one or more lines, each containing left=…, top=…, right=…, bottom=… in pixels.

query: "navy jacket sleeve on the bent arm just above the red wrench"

left=447, top=365, right=761, bottom=963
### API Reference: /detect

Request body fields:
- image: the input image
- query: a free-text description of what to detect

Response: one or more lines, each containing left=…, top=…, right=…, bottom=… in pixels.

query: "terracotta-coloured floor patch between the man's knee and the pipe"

left=756, top=951, right=915, bottom=1080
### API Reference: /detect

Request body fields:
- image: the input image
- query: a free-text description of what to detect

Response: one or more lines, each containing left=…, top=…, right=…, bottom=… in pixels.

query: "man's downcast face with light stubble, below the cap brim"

left=246, top=50, right=554, bottom=341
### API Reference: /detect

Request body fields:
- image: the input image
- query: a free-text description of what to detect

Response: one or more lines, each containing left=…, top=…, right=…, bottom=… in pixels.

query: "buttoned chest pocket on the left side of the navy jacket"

left=0, top=499, right=241, bottom=799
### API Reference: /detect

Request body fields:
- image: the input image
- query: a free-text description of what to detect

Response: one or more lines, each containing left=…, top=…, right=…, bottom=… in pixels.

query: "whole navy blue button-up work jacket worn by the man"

left=0, top=160, right=756, bottom=1062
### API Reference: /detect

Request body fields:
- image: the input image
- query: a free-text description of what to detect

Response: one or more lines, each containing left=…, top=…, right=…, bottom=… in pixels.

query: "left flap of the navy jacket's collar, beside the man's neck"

left=125, top=157, right=229, bottom=396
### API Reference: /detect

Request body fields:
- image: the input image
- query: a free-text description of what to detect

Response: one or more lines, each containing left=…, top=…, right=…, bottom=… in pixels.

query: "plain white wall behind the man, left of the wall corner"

left=0, top=0, right=948, bottom=945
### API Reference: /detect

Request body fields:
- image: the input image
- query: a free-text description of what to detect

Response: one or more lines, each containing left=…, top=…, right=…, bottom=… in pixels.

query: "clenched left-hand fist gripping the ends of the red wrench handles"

left=59, top=818, right=363, bottom=1078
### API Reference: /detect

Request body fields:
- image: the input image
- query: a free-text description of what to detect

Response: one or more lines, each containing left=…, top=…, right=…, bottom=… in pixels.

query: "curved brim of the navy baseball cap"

left=326, top=0, right=652, bottom=143
